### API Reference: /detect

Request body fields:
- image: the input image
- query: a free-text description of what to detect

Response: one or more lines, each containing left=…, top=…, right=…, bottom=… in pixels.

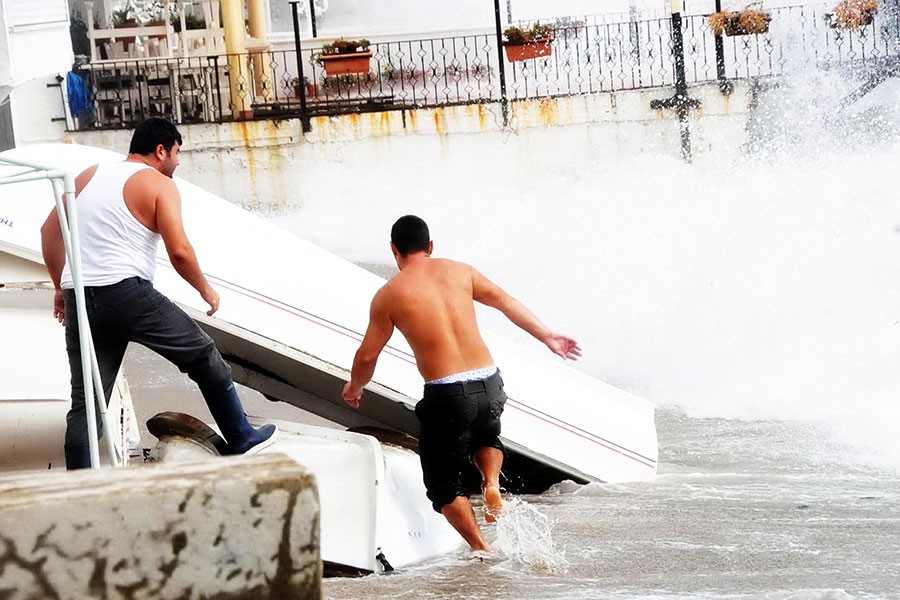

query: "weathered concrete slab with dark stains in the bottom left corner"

left=0, top=454, right=322, bottom=600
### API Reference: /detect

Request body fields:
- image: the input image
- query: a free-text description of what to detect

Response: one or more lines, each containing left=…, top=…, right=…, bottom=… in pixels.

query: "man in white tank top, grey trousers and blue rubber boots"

left=41, top=118, right=277, bottom=469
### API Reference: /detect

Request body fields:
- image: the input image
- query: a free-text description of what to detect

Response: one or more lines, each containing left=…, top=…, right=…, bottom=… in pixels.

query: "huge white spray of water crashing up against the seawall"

left=281, top=61, right=900, bottom=465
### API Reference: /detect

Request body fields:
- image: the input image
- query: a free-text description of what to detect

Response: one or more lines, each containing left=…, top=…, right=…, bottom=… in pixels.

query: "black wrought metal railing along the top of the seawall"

left=68, top=6, right=900, bottom=129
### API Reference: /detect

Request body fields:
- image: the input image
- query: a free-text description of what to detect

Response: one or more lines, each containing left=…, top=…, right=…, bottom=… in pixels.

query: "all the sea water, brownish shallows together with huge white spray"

left=251, top=63, right=900, bottom=600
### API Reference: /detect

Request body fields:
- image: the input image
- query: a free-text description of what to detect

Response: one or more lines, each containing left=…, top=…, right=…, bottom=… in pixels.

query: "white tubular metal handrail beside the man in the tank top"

left=0, top=156, right=119, bottom=469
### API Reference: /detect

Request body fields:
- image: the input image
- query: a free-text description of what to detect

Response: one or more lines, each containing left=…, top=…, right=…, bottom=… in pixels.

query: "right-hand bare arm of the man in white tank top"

left=154, top=176, right=219, bottom=316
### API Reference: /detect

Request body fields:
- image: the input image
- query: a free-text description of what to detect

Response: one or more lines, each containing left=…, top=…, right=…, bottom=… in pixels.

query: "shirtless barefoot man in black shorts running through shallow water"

left=343, top=215, right=581, bottom=551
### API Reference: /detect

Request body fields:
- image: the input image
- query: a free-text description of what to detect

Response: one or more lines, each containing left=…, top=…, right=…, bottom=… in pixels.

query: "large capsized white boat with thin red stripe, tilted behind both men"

left=0, top=144, right=658, bottom=491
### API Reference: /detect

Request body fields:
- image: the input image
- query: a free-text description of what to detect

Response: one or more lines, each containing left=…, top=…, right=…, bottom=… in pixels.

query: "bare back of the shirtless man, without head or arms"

left=374, top=258, right=494, bottom=381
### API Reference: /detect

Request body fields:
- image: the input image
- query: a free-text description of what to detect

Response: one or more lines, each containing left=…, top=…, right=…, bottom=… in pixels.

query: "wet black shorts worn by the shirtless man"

left=416, top=371, right=506, bottom=512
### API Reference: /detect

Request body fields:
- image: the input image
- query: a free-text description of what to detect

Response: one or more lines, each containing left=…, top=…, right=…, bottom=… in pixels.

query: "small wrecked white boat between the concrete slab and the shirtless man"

left=150, top=413, right=465, bottom=575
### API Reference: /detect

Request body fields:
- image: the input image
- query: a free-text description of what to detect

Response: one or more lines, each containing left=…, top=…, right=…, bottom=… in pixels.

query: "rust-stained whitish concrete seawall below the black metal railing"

left=66, top=82, right=753, bottom=210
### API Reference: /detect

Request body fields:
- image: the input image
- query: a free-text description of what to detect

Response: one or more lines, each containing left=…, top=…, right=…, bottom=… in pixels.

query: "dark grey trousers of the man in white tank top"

left=65, top=277, right=234, bottom=469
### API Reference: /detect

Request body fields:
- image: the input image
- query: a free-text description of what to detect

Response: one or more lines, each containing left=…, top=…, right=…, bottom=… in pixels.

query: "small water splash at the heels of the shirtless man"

left=493, top=498, right=569, bottom=575
